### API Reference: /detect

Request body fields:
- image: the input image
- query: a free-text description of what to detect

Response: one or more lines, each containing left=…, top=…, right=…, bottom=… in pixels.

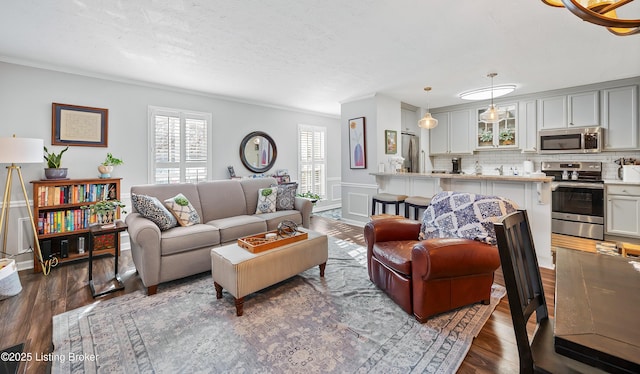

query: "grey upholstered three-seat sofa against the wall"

left=125, top=178, right=313, bottom=295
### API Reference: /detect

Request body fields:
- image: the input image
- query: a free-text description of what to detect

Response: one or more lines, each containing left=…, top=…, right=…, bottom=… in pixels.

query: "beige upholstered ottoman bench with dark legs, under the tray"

left=211, top=229, right=329, bottom=316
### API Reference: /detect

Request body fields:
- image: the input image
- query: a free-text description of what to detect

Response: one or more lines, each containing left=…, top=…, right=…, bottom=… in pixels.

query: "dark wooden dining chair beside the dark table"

left=494, top=210, right=604, bottom=374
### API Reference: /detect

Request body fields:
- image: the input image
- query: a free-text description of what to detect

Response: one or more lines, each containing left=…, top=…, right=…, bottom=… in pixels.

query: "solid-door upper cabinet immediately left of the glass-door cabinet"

left=429, top=109, right=473, bottom=155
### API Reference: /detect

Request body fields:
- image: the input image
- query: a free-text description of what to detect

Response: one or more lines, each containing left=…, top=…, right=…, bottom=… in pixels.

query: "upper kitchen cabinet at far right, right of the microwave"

left=602, top=85, right=639, bottom=151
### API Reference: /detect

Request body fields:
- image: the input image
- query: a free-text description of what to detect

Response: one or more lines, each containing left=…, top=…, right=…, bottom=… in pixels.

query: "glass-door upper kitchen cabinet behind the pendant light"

left=475, top=104, right=518, bottom=150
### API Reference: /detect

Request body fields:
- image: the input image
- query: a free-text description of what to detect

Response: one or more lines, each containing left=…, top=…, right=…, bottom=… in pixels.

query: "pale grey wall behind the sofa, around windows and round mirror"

left=0, top=62, right=342, bottom=261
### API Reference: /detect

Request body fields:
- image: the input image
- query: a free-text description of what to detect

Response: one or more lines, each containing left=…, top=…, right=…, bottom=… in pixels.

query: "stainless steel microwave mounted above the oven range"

left=538, top=127, right=604, bottom=153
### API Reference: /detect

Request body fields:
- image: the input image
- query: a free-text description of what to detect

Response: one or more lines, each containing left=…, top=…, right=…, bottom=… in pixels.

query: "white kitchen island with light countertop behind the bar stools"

left=371, top=173, right=554, bottom=268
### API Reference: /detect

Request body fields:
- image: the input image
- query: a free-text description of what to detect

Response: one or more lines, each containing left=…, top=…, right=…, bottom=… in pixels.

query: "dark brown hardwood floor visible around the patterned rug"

left=0, top=216, right=555, bottom=374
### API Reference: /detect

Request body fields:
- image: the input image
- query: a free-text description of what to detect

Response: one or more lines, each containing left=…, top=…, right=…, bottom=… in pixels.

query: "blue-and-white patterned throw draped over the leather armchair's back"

left=419, top=191, right=518, bottom=245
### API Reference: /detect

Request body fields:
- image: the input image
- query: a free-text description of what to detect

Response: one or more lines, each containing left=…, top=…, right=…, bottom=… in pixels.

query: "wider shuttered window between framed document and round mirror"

left=149, top=107, right=211, bottom=184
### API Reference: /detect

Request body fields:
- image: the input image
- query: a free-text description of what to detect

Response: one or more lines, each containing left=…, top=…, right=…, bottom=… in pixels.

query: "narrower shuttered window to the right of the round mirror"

left=298, top=125, right=327, bottom=197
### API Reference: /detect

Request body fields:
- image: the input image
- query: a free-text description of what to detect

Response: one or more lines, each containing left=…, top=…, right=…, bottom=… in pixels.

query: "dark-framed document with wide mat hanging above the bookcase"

left=51, top=103, right=109, bottom=147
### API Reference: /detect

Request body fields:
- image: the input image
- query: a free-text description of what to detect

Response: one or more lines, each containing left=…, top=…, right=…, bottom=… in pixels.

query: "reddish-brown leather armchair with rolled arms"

left=364, top=218, right=500, bottom=323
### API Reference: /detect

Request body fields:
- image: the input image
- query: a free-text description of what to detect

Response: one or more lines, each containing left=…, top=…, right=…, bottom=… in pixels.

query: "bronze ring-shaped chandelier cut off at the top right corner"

left=542, top=0, right=640, bottom=36
